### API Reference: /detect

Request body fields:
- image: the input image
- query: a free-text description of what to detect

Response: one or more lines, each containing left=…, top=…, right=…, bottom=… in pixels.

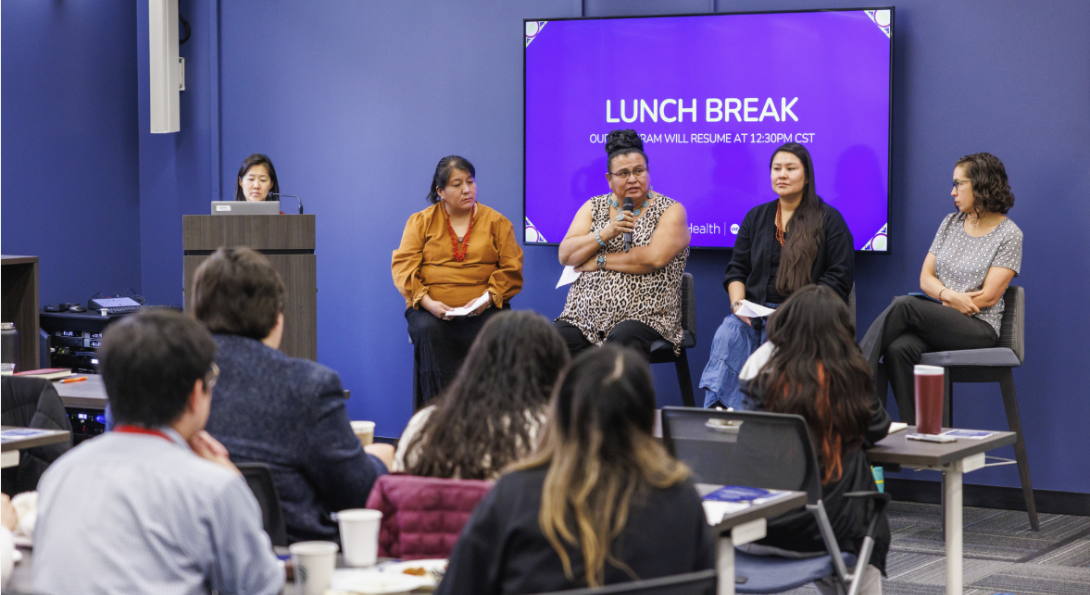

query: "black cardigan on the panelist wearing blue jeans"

left=723, top=198, right=856, bottom=305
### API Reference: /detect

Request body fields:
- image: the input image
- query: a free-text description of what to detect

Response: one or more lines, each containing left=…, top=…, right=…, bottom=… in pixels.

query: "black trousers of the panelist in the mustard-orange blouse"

left=405, top=307, right=501, bottom=412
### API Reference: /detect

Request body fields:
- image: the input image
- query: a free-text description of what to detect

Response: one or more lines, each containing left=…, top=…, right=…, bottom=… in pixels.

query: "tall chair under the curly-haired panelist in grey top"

left=920, top=286, right=1041, bottom=531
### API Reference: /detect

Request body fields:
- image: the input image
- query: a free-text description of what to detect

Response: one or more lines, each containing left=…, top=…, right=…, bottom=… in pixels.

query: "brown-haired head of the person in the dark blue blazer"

left=193, top=246, right=284, bottom=341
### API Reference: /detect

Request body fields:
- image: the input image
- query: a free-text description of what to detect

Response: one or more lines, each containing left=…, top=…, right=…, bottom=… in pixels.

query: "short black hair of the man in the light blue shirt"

left=98, top=311, right=216, bottom=428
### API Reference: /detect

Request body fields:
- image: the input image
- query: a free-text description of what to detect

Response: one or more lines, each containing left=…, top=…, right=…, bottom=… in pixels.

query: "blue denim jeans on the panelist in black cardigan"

left=700, top=304, right=778, bottom=409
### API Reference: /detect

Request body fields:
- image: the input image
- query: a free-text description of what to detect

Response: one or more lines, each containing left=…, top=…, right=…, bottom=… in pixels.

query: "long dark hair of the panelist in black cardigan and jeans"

left=768, top=143, right=825, bottom=296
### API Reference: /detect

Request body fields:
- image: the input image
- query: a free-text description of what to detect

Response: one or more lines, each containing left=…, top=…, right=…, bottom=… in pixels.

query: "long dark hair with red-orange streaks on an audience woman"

left=753, top=286, right=874, bottom=484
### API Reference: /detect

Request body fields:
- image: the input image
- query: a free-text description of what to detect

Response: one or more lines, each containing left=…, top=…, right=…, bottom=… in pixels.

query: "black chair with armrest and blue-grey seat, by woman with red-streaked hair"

left=663, top=406, right=889, bottom=595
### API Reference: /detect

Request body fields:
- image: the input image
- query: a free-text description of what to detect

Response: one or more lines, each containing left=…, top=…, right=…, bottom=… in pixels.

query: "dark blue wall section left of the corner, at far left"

left=0, top=0, right=146, bottom=305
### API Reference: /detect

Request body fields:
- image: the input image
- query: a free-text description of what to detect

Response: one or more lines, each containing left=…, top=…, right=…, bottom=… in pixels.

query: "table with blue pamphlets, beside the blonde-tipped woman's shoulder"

left=697, top=484, right=807, bottom=595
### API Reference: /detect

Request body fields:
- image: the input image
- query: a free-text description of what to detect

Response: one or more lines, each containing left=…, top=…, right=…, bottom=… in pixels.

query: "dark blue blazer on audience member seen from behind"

left=205, top=335, right=386, bottom=543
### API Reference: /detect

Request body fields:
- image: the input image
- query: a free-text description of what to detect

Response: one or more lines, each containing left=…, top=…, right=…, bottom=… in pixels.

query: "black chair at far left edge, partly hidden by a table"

left=0, top=376, right=72, bottom=496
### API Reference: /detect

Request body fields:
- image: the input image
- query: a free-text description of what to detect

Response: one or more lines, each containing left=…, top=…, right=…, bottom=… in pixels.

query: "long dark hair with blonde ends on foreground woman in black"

left=516, top=344, right=689, bottom=586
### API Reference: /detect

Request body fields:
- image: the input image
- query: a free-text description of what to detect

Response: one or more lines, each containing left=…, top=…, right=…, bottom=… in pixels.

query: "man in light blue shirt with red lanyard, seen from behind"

left=33, top=311, right=284, bottom=595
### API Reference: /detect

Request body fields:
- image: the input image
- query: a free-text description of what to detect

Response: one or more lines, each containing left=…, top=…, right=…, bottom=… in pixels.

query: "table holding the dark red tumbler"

left=867, top=426, right=1016, bottom=595
